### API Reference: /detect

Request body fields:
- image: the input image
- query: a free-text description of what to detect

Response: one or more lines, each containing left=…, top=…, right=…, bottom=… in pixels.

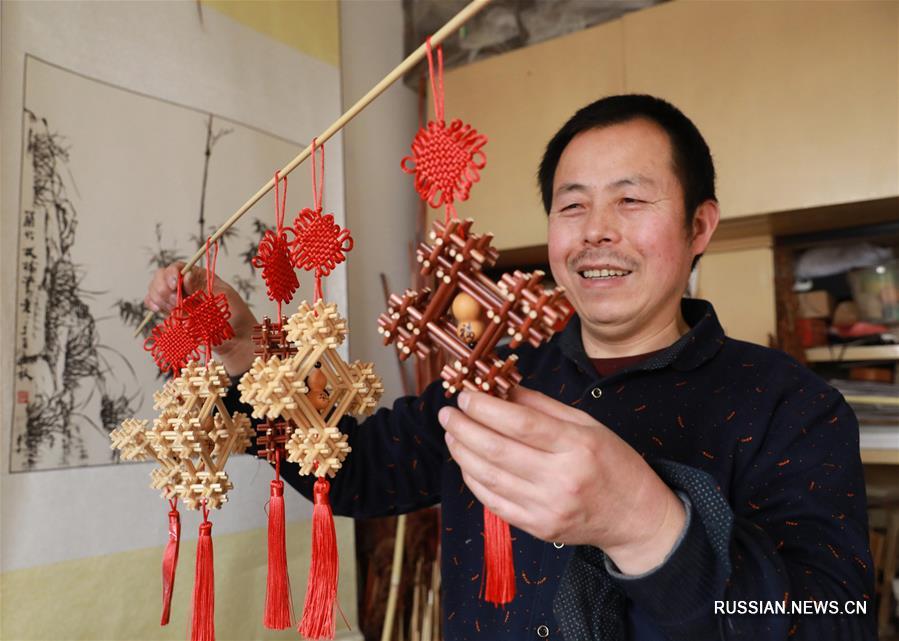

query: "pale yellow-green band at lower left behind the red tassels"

left=0, top=510, right=359, bottom=641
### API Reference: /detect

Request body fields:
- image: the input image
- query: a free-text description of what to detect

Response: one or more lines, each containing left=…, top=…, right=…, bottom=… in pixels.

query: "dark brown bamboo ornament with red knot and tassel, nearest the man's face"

left=378, top=43, right=572, bottom=605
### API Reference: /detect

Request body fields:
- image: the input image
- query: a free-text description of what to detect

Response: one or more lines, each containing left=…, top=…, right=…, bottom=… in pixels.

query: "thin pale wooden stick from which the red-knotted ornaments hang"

left=134, top=0, right=490, bottom=336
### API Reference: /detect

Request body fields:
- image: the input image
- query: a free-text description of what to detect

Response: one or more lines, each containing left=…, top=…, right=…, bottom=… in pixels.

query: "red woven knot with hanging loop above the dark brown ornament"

left=400, top=38, right=487, bottom=222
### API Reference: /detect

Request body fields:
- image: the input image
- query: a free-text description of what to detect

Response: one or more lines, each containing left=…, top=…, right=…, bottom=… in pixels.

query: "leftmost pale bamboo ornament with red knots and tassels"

left=110, top=242, right=252, bottom=641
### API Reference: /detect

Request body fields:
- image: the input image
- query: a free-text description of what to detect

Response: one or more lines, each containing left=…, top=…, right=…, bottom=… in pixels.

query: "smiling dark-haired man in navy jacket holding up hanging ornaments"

left=147, top=95, right=875, bottom=641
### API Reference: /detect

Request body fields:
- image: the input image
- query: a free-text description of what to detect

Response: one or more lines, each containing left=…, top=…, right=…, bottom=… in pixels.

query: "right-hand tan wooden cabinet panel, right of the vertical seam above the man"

left=623, top=1, right=899, bottom=218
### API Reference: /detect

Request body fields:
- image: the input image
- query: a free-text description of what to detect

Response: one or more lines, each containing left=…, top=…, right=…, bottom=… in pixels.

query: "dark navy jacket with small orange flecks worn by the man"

left=231, top=300, right=876, bottom=641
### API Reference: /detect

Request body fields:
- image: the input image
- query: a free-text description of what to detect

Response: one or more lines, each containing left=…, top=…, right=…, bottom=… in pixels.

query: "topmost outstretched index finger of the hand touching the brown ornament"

left=458, top=390, right=561, bottom=452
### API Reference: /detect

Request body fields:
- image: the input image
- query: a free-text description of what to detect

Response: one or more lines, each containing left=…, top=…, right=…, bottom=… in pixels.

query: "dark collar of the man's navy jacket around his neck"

left=558, top=298, right=724, bottom=380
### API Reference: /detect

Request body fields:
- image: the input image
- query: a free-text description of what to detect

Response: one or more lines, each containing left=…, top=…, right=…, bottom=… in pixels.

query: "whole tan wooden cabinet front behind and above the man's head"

left=446, top=0, right=899, bottom=249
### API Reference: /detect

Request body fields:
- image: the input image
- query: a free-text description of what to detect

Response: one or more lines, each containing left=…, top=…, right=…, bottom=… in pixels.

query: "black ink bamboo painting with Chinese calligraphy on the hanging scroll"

left=9, top=57, right=320, bottom=472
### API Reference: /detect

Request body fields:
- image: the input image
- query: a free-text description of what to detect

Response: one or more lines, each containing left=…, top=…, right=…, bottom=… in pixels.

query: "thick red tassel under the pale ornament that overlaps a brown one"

left=299, top=478, right=337, bottom=639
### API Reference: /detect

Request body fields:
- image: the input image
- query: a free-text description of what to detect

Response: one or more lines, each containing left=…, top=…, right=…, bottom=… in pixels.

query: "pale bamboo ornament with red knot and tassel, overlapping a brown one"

left=238, top=140, right=383, bottom=639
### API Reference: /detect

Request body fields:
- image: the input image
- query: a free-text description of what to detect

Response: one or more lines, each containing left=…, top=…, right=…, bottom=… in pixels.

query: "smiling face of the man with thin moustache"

left=548, top=119, right=717, bottom=341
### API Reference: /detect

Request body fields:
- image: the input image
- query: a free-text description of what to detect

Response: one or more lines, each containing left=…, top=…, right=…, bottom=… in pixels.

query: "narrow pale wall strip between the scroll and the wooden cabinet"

left=341, top=0, right=418, bottom=404
